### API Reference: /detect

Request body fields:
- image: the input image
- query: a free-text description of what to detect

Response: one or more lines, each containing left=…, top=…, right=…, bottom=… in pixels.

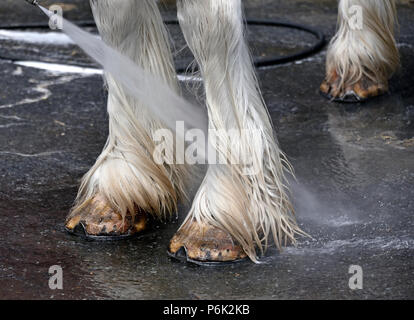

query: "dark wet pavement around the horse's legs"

left=0, top=0, right=414, bottom=299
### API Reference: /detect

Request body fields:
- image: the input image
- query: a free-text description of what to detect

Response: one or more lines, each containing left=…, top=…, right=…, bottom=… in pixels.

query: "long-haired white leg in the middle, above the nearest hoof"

left=177, top=0, right=302, bottom=262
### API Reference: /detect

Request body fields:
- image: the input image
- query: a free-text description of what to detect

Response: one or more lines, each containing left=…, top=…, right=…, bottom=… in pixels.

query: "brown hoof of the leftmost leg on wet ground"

left=65, top=195, right=148, bottom=241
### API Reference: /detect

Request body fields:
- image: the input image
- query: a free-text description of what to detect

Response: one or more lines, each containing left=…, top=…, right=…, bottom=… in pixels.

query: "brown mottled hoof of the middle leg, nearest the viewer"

left=168, top=221, right=247, bottom=266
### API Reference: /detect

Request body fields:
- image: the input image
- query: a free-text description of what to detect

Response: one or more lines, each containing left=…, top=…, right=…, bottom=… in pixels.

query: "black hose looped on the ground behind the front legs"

left=0, top=19, right=326, bottom=73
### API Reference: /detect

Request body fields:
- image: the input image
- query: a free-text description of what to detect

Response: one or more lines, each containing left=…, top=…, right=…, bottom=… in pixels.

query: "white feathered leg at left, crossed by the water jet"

left=69, top=0, right=189, bottom=224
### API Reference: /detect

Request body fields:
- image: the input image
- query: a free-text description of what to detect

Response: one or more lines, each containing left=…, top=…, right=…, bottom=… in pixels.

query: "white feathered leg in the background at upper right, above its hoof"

left=326, top=0, right=400, bottom=90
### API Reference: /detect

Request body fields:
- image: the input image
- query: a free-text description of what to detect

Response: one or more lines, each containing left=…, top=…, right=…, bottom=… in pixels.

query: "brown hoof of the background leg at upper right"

left=319, top=74, right=388, bottom=103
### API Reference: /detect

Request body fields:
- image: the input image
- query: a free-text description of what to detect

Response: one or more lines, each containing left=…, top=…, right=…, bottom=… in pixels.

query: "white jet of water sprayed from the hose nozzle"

left=21, top=0, right=208, bottom=159
